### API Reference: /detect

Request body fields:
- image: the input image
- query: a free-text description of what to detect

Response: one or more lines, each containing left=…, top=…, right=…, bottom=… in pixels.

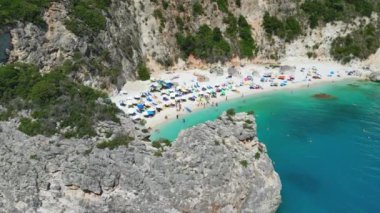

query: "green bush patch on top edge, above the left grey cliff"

left=65, top=0, right=111, bottom=37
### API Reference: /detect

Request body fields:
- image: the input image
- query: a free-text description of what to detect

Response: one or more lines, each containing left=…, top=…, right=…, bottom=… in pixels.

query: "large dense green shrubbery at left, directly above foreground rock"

left=0, top=64, right=119, bottom=137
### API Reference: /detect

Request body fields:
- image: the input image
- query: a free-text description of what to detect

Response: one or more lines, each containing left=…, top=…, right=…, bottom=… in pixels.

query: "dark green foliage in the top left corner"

left=0, top=0, right=51, bottom=26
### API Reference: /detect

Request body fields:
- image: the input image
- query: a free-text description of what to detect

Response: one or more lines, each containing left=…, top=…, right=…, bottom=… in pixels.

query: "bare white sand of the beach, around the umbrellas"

left=111, top=59, right=367, bottom=128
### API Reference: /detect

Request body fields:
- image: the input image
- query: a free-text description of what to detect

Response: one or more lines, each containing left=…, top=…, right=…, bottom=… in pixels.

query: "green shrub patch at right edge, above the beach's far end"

left=330, top=24, right=380, bottom=63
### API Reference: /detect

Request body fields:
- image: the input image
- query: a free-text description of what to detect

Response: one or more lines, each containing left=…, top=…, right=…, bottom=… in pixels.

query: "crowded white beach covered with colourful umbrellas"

left=111, top=60, right=368, bottom=129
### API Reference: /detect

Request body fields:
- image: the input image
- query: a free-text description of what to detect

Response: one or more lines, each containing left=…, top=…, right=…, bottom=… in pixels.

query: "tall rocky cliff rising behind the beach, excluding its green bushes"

left=5, top=0, right=378, bottom=89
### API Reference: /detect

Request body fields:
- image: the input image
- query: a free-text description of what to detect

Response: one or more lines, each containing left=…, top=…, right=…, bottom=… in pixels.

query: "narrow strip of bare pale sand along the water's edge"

left=145, top=76, right=365, bottom=129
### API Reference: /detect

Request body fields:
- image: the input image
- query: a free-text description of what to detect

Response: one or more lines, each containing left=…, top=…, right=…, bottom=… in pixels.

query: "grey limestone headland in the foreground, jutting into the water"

left=0, top=114, right=281, bottom=213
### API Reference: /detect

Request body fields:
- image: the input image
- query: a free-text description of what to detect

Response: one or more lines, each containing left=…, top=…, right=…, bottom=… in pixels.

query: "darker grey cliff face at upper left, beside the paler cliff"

left=9, top=0, right=141, bottom=91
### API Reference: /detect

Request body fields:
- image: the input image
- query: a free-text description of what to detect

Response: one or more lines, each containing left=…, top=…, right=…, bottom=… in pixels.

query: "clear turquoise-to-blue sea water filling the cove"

left=152, top=82, right=380, bottom=213
